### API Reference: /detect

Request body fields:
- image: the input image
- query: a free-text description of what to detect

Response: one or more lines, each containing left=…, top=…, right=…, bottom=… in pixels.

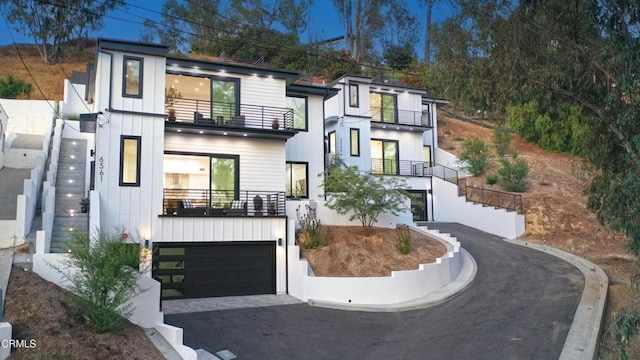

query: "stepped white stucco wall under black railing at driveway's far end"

left=433, top=177, right=525, bottom=239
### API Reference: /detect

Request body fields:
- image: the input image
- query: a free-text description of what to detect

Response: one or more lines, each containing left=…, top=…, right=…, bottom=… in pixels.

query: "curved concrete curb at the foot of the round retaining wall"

left=308, top=247, right=478, bottom=312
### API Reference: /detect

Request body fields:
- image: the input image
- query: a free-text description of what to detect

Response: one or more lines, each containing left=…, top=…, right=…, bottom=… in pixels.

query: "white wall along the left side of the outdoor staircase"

left=36, top=119, right=64, bottom=254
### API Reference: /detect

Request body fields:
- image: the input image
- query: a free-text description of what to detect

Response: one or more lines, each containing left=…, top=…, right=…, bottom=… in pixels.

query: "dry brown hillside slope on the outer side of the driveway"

left=438, top=113, right=640, bottom=359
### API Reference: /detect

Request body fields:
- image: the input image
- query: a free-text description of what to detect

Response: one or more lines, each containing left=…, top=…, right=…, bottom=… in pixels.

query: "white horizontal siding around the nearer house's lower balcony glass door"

left=164, top=134, right=285, bottom=191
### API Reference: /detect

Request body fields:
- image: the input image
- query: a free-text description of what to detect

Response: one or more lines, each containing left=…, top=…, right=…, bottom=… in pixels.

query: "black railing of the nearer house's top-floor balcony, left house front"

left=165, top=99, right=293, bottom=130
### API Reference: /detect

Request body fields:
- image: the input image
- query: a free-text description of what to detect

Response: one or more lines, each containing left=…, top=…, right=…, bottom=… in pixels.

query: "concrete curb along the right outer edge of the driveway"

left=504, top=239, right=609, bottom=360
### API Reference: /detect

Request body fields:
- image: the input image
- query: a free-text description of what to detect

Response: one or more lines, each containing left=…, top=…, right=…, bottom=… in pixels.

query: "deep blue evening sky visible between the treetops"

left=0, top=0, right=460, bottom=54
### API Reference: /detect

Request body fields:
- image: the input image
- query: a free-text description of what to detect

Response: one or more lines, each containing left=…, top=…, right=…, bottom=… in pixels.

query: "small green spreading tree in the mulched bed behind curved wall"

left=324, top=166, right=409, bottom=234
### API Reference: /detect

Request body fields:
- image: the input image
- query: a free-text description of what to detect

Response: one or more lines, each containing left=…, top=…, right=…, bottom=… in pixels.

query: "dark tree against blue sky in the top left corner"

left=0, top=0, right=125, bottom=64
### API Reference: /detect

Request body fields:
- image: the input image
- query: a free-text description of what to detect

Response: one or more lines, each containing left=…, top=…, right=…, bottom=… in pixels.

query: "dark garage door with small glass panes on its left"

left=153, top=241, right=276, bottom=300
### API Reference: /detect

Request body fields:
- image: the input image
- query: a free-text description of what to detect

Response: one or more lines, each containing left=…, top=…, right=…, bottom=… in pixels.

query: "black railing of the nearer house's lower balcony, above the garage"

left=162, top=189, right=286, bottom=217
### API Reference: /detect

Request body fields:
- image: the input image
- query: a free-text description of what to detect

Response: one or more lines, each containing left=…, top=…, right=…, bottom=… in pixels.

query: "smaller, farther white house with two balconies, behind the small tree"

left=325, top=75, right=447, bottom=221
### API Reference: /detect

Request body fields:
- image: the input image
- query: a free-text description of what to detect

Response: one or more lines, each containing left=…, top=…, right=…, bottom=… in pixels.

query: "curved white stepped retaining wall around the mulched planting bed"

left=289, top=227, right=462, bottom=305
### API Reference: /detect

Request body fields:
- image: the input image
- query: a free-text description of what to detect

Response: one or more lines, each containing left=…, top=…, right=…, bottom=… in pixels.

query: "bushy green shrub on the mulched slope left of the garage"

left=53, top=229, right=144, bottom=333
